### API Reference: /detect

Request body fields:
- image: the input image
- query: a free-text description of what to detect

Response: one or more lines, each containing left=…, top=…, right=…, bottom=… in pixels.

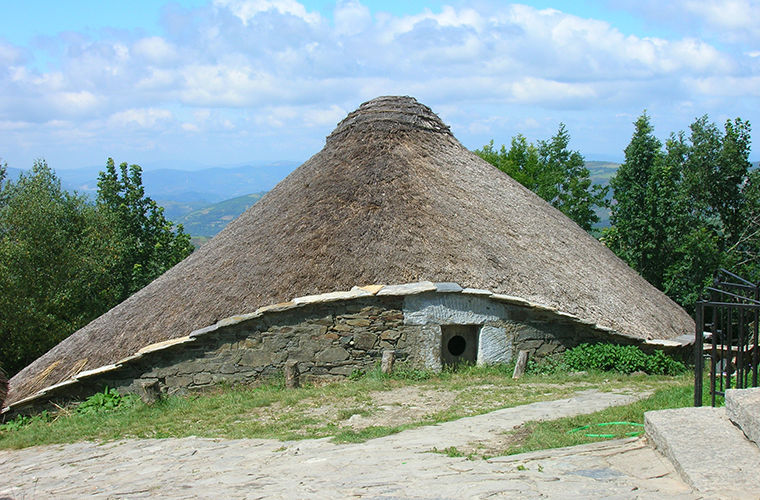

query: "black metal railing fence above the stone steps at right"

left=694, top=269, right=760, bottom=406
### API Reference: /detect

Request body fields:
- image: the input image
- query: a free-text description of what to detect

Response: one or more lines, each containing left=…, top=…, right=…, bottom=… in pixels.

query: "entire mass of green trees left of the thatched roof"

left=0, top=160, right=190, bottom=374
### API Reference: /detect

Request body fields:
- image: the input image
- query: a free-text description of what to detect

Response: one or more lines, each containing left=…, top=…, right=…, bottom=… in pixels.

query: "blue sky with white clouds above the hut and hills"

left=0, top=0, right=760, bottom=170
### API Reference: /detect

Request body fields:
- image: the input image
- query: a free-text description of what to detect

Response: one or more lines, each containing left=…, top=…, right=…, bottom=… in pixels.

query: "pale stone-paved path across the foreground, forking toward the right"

left=0, top=391, right=699, bottom=500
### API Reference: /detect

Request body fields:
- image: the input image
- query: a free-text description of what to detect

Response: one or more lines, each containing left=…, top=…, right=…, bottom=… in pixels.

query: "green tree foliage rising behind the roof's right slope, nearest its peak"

left=475, top=123, right=607, bottom=231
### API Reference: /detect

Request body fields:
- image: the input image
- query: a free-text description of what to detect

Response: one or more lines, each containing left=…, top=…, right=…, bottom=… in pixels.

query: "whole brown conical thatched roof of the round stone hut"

left=9, top=97, right=693, bottom=402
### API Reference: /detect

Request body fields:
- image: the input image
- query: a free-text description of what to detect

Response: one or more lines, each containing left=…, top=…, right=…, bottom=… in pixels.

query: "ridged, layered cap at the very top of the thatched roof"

left=327, top=96, right=451, bottom=143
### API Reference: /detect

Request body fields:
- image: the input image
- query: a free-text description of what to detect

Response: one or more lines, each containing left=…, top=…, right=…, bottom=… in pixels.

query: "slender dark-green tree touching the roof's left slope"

left=97, top=158, right=193, bottom=300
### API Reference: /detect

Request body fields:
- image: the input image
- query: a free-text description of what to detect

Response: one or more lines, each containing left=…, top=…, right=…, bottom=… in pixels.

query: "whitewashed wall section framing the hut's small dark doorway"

left=404, top=293, right=513, bottom=370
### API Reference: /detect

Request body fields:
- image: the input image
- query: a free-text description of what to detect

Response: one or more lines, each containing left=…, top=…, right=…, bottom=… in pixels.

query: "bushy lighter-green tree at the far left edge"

left=0, top=160, right=115, bottom=374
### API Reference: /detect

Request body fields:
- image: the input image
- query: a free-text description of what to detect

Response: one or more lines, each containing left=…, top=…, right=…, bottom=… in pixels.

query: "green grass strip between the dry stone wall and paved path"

left=0, top=365, right=692, bottom=452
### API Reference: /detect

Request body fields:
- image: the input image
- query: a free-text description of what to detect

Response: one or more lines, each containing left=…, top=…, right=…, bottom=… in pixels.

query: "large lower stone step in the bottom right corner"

left=644, top=407, right=760, bottom=498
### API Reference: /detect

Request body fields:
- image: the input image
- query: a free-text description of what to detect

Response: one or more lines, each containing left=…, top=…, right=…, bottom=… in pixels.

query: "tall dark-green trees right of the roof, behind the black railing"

left=603, top=112, right=760, bottom=308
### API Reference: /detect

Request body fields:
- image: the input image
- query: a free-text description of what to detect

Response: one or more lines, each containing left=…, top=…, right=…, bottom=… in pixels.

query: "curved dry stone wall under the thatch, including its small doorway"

left=1, top=282, right=688, bottom=411
